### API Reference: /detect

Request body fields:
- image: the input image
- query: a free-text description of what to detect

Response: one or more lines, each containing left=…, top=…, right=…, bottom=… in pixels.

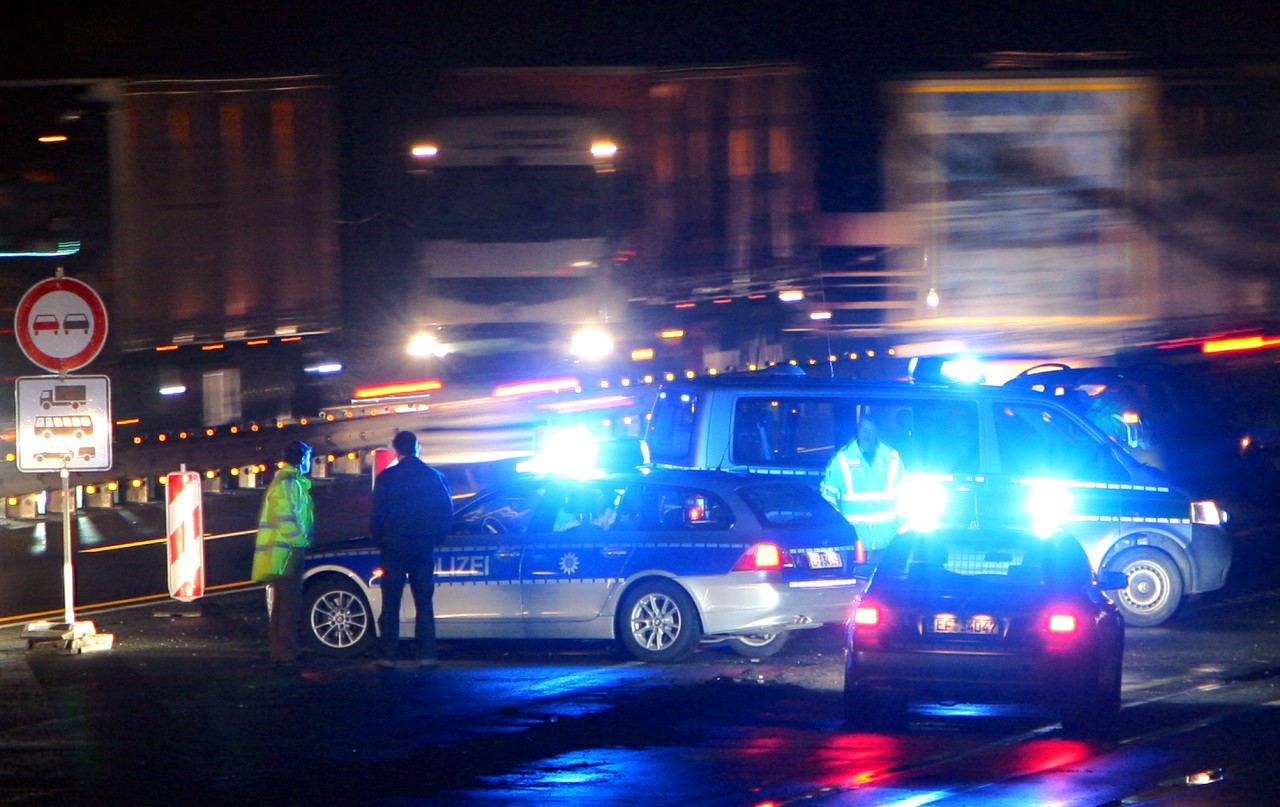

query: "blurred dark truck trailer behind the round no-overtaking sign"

left=106, top=76, right=342, bottom=428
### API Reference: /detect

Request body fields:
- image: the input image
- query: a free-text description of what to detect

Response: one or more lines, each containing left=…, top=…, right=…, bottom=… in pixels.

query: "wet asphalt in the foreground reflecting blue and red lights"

left=0, top=532, right=1280, bottom=807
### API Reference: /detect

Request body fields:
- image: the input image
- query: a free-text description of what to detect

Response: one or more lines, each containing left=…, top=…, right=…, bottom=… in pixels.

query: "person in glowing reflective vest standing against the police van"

left=822, top=412, right=904, bottom=552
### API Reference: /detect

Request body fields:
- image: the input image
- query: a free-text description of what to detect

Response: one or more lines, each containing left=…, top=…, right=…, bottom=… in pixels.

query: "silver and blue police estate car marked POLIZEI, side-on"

left=303, top=469, right=861, bottom=661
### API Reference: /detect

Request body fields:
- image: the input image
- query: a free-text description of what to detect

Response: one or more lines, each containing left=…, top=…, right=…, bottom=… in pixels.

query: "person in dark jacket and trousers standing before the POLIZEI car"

left=370, top=432, right=453, bottom=667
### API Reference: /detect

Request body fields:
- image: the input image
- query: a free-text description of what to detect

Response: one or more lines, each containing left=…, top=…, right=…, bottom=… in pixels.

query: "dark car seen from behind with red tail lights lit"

left=845, top=529, right=1126, bottom=733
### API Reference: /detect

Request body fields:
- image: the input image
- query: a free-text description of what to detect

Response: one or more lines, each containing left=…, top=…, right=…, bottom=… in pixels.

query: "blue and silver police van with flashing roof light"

left=644, top=373, right=1231, bottom=626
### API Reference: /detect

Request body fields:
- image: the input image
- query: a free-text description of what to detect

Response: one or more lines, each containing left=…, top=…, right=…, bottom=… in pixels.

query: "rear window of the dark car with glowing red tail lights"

left=877, top=533, right=1092, bottom=588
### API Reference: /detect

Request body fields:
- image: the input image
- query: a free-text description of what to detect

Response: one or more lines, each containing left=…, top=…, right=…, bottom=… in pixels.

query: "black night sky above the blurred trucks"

left=0, top=0, right=1280, bottom=216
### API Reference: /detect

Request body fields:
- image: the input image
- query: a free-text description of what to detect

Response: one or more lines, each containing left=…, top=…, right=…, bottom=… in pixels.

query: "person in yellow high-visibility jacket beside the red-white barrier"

left=253, top=441, right=315, bottom=669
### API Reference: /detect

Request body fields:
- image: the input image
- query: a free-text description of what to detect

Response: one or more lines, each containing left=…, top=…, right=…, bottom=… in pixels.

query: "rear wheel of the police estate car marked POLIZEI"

left=617, top=579, right=703, bottom=661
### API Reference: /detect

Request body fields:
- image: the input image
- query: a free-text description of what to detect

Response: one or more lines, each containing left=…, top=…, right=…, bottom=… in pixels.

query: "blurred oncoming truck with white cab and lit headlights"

left=408, top=64, right=815, bottom=376
